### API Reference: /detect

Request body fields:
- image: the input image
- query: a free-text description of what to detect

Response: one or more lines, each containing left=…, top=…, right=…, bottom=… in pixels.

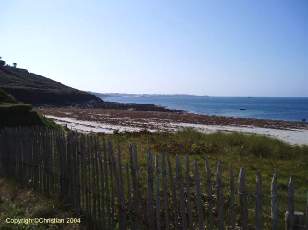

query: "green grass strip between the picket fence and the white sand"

left=107, top=129, right=308, bottom=214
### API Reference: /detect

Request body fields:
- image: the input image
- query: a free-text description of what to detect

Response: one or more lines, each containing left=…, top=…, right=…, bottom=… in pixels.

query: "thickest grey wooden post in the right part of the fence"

left=239, top=168, right=248, bottom=230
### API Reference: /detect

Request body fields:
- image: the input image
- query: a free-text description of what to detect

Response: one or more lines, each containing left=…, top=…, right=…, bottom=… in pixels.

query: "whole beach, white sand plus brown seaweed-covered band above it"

left=39, top=107, right=308, bottom=145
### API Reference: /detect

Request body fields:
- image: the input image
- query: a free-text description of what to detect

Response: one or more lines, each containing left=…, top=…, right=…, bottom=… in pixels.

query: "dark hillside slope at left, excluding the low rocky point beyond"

left=0, top=65, right=102, bottom=105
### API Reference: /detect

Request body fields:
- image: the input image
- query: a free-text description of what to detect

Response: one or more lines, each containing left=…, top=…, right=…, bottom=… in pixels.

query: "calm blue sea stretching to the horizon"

left=102, top=96, right=308, bottom=121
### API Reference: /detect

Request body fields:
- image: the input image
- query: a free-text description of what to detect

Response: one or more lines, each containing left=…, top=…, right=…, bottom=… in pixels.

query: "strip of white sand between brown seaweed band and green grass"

left=46, top=115, right=308, bottom=145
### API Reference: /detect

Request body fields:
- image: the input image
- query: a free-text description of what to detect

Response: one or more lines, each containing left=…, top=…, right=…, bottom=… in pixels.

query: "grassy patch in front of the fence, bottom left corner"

left=0, top=178, right=82, bottom=230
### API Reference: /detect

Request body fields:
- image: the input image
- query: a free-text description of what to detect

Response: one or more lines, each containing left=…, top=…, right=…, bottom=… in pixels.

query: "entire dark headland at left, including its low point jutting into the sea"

left=0, top=57, right=177, bottom=112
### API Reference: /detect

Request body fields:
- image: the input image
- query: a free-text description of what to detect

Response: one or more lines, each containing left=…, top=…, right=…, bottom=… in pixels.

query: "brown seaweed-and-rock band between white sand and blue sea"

left=37, top=107, right=308, bottom=130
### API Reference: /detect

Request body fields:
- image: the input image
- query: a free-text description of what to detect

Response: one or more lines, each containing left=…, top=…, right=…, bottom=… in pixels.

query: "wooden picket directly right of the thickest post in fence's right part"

left=255, top=171, right=263, bottom=230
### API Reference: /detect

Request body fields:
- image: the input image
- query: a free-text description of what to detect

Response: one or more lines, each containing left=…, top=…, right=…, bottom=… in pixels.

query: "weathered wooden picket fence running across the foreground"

left=0, top=128, right=308, bottom=230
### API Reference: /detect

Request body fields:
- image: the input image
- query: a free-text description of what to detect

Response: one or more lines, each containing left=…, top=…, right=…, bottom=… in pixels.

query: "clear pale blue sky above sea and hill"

left=0, top=0, right=308, bottom=96
